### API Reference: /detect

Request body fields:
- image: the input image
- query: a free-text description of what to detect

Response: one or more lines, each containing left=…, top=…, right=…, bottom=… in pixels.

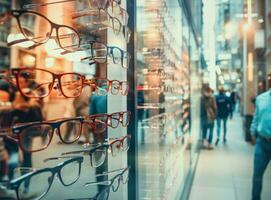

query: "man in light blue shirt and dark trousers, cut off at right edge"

left=250, top=73, right=271, bottom=200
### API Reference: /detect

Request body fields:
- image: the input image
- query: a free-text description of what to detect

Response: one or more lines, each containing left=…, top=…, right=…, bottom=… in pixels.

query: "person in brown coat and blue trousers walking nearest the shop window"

left=201, top=87, right=217, bottom=149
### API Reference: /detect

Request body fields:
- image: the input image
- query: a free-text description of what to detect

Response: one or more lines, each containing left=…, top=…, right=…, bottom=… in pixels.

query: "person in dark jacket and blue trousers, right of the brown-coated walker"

left=215, top=87, right=231, bottom=145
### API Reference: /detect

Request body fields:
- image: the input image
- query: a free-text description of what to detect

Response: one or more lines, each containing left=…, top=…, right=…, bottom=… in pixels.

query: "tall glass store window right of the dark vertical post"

left=136, top=0, right=201, bottom=200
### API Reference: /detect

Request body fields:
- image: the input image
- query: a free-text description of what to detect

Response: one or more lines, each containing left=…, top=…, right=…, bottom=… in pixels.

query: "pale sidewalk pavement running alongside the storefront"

left=190, top=114, right=271, bottom=200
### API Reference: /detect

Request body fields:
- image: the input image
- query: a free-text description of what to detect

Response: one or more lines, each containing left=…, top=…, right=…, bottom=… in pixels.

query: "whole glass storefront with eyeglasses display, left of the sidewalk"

left=0, top=0, right=204, bottom=200
